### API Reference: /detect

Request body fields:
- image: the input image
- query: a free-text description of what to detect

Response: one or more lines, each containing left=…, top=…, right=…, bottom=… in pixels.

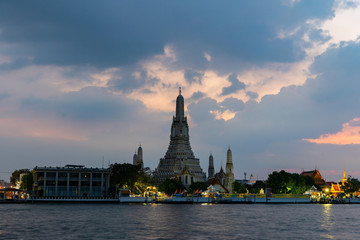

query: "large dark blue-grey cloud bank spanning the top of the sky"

left=0, top=0, right=332, bottom=68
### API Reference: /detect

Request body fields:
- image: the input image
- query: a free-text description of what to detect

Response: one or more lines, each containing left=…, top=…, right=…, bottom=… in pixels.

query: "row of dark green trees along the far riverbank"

left=10, top=167, right=360, bottom=195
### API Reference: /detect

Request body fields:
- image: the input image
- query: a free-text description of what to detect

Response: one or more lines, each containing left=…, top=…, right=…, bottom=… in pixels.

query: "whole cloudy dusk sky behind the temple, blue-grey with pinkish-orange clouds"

left=0, top=0, right=360, bottom=181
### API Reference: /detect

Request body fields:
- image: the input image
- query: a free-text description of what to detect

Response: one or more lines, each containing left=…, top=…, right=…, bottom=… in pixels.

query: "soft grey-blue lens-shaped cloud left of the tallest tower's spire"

left=21, top=87, right=145, bottom=123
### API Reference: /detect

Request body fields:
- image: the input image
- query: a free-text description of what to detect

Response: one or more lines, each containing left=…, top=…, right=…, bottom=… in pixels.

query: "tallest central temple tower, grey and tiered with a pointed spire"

left=154, top=88, right=204, bottom=187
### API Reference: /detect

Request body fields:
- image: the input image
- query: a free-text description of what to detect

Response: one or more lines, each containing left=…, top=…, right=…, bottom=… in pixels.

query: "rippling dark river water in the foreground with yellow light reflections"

left=0, top=204, right=360, bottom=239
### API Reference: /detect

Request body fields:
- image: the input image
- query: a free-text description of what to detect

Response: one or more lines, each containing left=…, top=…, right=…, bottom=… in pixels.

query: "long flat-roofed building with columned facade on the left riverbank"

left=33, top=165, right=111, bottom=197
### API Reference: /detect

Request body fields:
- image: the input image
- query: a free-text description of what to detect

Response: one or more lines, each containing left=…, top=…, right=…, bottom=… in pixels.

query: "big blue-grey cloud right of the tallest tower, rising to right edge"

left=189, top=41, right=360, bottom=157
